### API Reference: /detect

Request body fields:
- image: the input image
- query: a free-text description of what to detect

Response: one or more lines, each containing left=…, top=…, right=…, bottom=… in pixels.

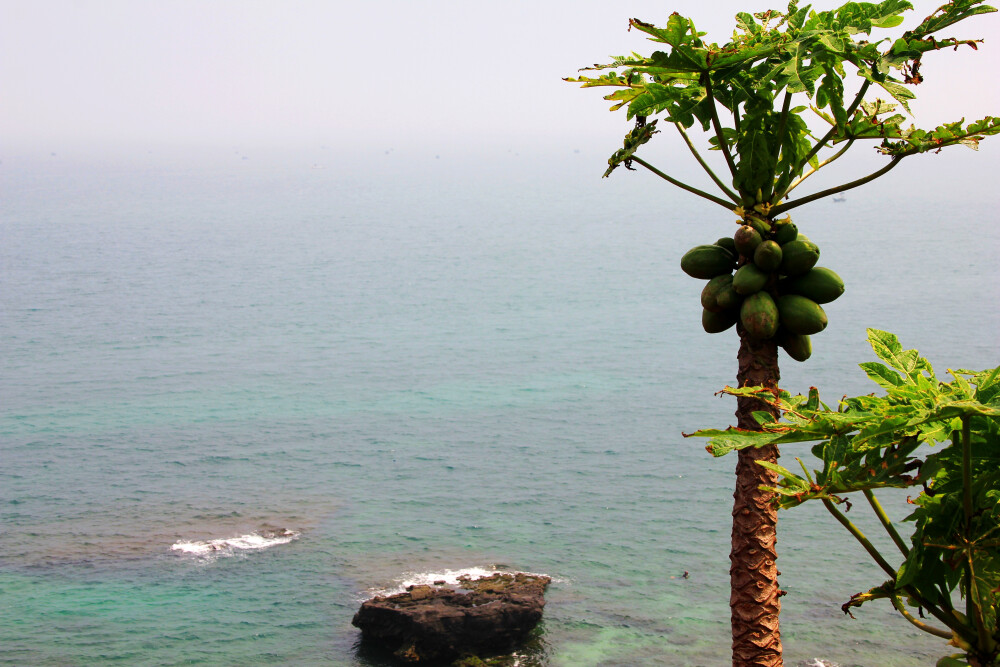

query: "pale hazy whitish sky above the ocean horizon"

left=0, top=0, right=1000, bottom=151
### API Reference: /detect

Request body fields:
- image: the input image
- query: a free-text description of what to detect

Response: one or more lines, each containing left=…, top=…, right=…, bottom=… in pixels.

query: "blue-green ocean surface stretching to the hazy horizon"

left=0, top=150, right=1000, bottom=667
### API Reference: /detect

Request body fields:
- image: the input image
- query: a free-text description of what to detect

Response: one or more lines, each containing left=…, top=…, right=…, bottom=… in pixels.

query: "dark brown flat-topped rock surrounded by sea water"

left=352, top=572, right=552, bottom=662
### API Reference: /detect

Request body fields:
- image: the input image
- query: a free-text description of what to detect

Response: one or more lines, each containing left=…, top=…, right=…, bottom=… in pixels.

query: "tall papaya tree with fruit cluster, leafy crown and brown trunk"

left=566, top=0, right=1000, bottom=665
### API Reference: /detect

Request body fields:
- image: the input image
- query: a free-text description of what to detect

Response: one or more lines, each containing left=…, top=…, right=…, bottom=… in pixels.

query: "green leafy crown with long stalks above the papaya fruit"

left=566, top=0, right=1000, bottom=215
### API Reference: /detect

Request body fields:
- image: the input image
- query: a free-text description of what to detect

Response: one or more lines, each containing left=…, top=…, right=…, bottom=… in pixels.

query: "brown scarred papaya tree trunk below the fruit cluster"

left=729, top=324, right=784, bottom=667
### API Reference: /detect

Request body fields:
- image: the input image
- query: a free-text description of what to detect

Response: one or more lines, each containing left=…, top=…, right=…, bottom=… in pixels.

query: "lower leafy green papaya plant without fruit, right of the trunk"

left=692, top=329, right=1000, bottom=665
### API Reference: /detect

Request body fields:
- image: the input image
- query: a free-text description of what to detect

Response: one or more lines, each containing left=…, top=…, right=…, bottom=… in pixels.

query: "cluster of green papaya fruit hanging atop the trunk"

left=681, top=218, right=844, bottom=361
